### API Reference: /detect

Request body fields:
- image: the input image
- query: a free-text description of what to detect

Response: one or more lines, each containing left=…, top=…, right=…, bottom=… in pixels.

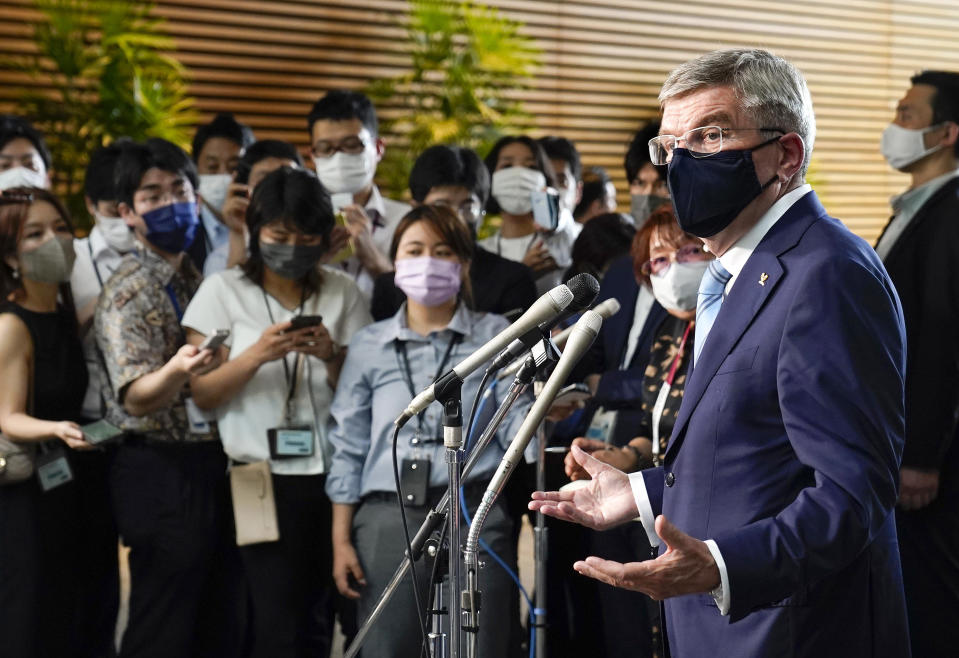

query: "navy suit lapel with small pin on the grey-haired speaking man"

left=666, top=193, right=825, bottom=457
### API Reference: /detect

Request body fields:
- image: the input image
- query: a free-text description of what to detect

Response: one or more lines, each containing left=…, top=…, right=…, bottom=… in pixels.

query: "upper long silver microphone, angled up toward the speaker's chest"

left=396, top=285, right=573, bottom=426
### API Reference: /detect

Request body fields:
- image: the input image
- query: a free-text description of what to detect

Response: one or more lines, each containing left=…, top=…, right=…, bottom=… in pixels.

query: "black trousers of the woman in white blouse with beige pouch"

left=240, top=474, right=335, bottom=658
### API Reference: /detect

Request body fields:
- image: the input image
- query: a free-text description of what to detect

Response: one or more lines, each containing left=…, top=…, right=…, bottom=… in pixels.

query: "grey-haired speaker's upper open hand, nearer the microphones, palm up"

left=529, top=445, right=639, bottom=530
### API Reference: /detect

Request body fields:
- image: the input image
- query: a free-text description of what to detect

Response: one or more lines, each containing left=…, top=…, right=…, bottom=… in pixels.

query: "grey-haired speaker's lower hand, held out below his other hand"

left=573, top=516, right=719, bottom=601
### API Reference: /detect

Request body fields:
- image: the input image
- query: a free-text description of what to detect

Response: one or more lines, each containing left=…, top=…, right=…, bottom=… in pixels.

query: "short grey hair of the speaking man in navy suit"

left=659, top=48, right=816, bottom=177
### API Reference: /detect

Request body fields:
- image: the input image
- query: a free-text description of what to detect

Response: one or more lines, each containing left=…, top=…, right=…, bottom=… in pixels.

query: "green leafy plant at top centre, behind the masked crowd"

left=366, top=0, right=539, bottom=198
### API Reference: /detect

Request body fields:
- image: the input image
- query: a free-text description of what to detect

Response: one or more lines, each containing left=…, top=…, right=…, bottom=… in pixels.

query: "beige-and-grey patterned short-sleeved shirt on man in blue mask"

left=94, top=247, right=217, bottom=441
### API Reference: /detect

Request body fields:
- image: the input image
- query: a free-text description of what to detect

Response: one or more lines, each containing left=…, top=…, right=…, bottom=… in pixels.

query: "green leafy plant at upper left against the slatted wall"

left=10, top=0, right=197, bottom=224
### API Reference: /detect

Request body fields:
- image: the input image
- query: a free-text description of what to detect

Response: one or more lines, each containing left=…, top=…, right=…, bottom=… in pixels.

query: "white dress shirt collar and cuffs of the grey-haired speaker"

left=629, top=184, right=812, bottom=615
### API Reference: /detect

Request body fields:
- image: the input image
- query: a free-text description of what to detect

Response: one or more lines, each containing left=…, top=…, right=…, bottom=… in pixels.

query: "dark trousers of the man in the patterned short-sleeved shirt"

left=110, top=441, right=243, bottom=658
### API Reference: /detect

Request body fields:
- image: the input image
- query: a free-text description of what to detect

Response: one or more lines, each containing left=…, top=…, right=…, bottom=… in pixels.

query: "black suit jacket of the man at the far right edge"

left=876, top=178, right=959, bottom=470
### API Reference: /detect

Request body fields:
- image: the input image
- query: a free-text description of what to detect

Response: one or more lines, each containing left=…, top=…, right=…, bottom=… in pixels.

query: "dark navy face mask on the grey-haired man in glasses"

left=667, top=137, right=780, bottom=238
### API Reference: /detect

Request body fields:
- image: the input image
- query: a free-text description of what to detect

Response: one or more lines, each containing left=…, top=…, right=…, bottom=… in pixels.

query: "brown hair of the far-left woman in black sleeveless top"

left=0, top=187, right=77, bottom=324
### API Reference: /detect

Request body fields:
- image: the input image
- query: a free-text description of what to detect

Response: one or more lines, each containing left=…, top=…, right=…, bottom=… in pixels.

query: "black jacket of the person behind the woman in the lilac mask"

left=370, top=245, right=537, bottom=321
